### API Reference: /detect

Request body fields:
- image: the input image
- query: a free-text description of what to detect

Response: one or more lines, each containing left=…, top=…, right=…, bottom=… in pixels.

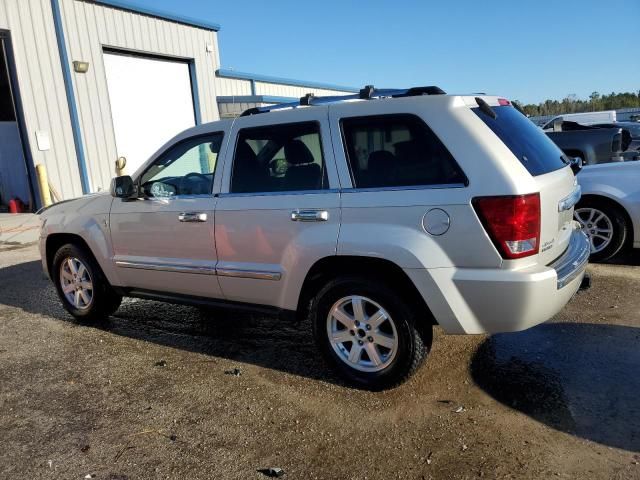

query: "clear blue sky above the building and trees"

left=133, top=0, right=640, bottom=103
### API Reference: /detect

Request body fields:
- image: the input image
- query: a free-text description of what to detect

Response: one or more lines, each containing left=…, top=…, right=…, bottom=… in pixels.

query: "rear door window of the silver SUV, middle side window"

left=230, top=122, right=328, bottom=193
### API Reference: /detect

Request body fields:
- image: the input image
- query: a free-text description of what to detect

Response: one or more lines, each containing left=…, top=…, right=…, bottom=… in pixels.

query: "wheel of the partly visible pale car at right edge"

left=574, top=198, right=629, bottom=262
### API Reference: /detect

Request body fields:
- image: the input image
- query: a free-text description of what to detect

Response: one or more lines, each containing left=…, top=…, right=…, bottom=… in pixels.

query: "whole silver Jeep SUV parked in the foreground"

left=40, top=87, right=589, bottom=389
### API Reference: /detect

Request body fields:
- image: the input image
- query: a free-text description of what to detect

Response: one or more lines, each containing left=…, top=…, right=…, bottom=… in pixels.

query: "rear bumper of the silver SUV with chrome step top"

left=406, top=230, right=589, bottom=334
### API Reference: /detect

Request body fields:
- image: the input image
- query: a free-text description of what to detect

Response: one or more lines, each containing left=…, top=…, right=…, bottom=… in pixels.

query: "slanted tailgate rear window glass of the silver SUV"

left=471, top=105, right=567, bottom=176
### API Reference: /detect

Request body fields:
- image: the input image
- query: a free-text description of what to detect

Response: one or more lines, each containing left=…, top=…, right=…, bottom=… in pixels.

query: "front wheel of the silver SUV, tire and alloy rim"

left=51, top=243, right=122, bottom=323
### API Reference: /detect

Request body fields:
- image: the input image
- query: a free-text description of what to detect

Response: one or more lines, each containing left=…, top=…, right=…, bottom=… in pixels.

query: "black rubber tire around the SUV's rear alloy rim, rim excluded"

left=310, top=277, right=430, bottom=390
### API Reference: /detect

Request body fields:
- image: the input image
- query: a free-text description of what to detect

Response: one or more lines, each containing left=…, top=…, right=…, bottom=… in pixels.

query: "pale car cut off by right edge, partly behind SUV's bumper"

left=574, top=161, right=640, bottom=260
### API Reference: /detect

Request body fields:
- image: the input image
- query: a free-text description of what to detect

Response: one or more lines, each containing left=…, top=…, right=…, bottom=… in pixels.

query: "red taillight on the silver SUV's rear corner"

left=473, top=193, right=540, bottom=259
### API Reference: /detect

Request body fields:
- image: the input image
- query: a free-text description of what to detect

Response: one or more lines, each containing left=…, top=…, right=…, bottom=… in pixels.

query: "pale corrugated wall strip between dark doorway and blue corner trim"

left=0, top=0, right=82, bottom=198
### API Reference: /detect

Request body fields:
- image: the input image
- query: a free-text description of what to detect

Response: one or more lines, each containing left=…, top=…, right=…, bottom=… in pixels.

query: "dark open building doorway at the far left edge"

left=0, top=31, right=35, bottom=209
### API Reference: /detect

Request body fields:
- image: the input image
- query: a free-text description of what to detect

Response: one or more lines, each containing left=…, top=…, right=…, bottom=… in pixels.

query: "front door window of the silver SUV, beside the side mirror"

left=140, top=133, right=224, bottom=197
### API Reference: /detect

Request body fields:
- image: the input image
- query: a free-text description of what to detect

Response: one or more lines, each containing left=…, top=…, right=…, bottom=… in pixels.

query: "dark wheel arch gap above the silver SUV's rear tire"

left=297, top=255, right=437, bottom=326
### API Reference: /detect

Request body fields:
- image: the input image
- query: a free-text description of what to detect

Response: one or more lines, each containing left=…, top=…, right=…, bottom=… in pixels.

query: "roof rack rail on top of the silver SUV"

left=240, top=85, right=446, bottom=117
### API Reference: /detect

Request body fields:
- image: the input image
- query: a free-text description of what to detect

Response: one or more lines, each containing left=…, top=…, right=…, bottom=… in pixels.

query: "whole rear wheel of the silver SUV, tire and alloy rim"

left=309, top=276, right=432, bottom=390
